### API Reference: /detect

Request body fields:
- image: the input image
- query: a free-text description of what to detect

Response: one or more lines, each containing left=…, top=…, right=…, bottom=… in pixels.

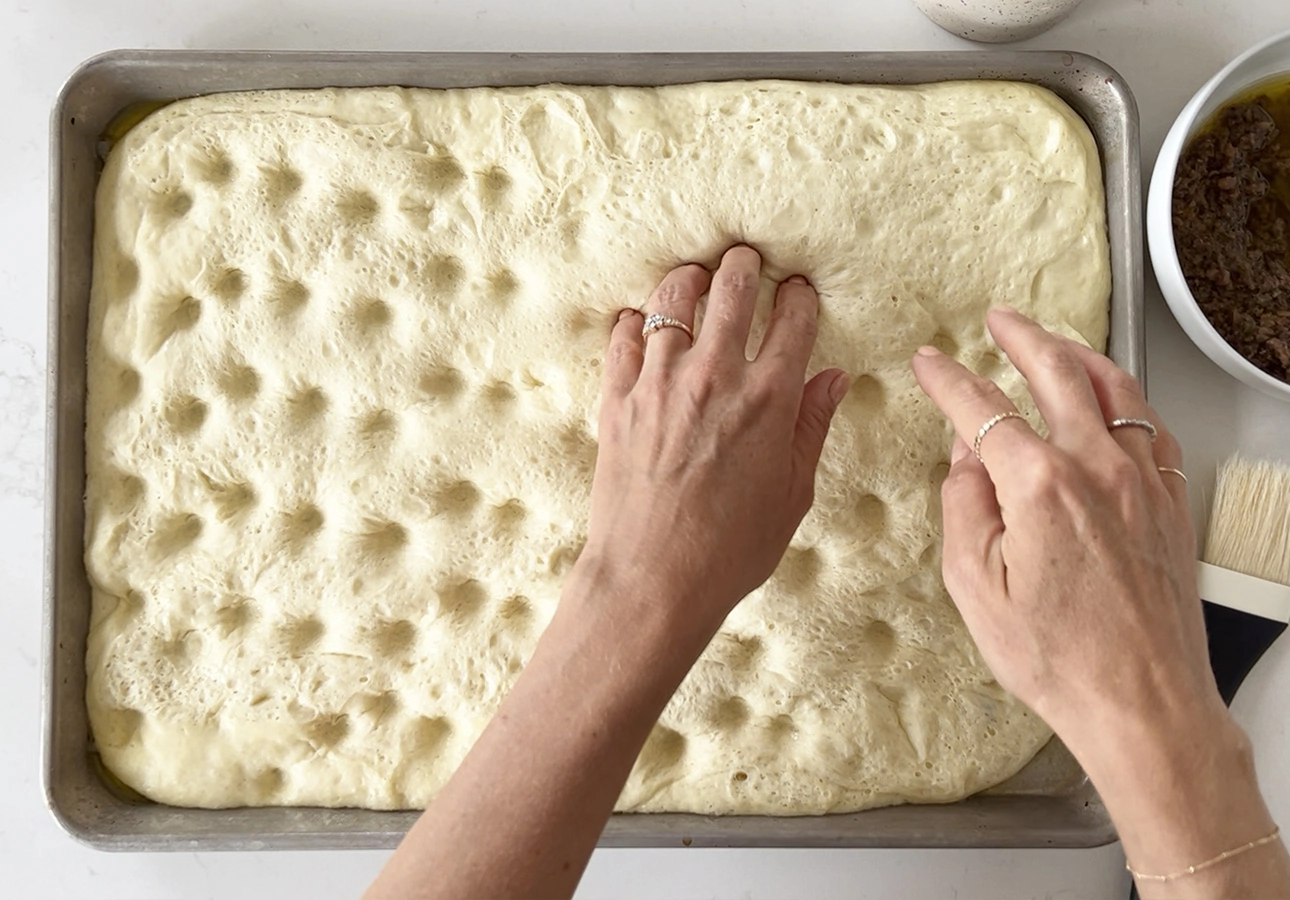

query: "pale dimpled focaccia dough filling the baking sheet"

left=85, top=83, right=1109, bottom=815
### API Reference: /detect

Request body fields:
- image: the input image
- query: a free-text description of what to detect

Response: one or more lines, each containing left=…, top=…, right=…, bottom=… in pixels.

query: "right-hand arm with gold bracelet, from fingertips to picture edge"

left=913, top=308, right=1290, bottom=896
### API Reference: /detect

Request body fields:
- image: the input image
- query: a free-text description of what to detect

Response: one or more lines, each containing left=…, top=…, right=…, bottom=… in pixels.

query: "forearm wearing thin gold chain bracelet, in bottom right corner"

left=1077, top=710, right=1290, bottom=900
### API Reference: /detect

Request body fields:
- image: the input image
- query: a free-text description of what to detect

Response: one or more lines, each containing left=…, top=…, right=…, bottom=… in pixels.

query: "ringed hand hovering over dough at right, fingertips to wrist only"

left=913, top=309, right=1207, bottom=745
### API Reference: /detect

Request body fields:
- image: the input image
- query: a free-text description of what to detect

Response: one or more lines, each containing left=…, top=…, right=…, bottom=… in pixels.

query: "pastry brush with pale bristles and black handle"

left=1196, top=456, right=1290, bottom=704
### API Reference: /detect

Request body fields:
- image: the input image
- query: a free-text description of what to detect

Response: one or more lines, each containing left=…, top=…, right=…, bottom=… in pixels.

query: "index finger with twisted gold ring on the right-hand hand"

left=913, top=347, right=1044, bottom=477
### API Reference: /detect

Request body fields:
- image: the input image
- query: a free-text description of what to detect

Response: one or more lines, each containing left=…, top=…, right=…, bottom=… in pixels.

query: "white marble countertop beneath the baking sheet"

left=0, top=0, right=1290, bottom=900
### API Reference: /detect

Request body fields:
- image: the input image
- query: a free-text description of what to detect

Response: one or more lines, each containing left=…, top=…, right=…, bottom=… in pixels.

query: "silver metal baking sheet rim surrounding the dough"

left=44, top=50, right=1144, bottom=851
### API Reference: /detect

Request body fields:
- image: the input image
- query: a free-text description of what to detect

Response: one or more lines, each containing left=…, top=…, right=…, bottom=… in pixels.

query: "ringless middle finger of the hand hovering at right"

left=986, top=307, right=1107, bottom=449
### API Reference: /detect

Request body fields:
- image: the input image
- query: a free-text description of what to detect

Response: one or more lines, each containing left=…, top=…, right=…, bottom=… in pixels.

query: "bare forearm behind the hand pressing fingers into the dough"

left=368, top=567, right=702, bottom=900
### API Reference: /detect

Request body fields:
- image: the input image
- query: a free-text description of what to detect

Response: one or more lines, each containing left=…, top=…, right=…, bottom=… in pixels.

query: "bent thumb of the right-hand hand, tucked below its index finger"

left=940, top=437, right=1004, bottom=611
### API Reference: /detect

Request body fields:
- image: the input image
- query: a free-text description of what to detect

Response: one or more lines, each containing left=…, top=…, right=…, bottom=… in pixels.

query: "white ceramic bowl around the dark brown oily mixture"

left=1147, top=31, right=1290, bottom=402
